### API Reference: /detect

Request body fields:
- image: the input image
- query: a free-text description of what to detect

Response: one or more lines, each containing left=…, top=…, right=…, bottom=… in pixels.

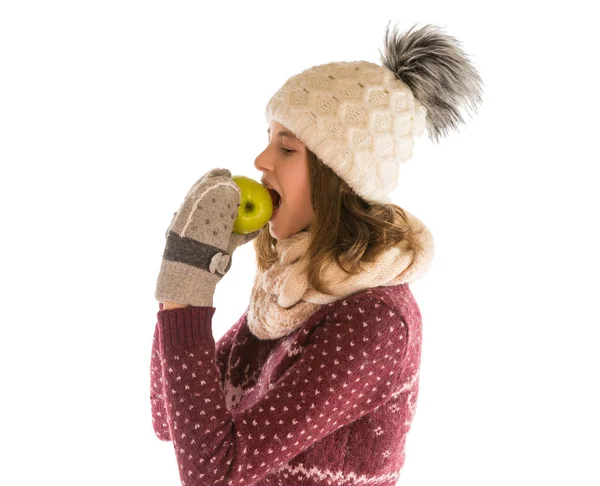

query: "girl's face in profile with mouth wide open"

left=254, top=121, right=314, bottom=240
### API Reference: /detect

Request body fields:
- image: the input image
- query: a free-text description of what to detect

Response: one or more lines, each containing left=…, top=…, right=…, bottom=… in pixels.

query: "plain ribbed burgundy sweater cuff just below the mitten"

left=158, top=306, right=216, bottom=348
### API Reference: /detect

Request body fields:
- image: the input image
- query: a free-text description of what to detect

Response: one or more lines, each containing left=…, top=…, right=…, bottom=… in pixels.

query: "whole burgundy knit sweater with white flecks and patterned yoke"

left=150, top=284, right=421, bottom=486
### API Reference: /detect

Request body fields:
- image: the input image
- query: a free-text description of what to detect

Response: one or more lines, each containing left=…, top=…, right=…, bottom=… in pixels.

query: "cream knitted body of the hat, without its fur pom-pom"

left=265, top=61, right=426, bottom=204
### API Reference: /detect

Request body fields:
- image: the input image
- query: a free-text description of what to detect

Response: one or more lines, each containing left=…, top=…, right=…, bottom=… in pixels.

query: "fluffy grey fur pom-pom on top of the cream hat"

left=379, top=23, right=483, bottom=142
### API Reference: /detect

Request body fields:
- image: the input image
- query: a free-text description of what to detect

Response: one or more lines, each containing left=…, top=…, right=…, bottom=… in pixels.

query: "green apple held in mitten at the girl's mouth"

left=231, top=175, right=273, bottom=235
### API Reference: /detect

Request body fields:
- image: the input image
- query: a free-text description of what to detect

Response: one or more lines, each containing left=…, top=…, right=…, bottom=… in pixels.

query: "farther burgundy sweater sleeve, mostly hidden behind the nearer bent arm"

left=150, top=302, right=244, bottom=442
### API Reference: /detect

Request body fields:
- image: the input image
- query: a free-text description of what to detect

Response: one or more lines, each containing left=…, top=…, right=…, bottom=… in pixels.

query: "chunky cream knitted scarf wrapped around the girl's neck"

left=247, top=210, right=434, bottom=339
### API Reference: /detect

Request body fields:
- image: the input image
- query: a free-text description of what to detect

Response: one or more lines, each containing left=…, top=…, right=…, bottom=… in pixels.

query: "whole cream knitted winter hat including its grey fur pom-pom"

left=266, top=23, right=482, bottom=204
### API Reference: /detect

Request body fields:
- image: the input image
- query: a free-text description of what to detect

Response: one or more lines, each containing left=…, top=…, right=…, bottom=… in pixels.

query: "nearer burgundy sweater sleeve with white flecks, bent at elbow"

left=158, top=297, right=408, bottom=486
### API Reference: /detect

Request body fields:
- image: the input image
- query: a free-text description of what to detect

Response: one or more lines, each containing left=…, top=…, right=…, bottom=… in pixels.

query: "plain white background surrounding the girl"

left=0, top=0, right=600, bottom=486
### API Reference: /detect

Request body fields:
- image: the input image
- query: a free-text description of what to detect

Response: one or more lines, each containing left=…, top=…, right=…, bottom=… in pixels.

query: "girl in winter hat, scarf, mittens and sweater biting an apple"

left=151, top=20, right=481, bottom=486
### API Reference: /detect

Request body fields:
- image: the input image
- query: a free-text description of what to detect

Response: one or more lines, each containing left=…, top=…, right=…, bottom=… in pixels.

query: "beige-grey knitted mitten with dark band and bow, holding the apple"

left=155, top=169, right=260, bottom=307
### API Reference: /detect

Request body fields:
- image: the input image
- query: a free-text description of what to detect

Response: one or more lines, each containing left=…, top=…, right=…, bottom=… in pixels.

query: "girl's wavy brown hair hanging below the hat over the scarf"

left=254, top=147, right=423, bottom=293
